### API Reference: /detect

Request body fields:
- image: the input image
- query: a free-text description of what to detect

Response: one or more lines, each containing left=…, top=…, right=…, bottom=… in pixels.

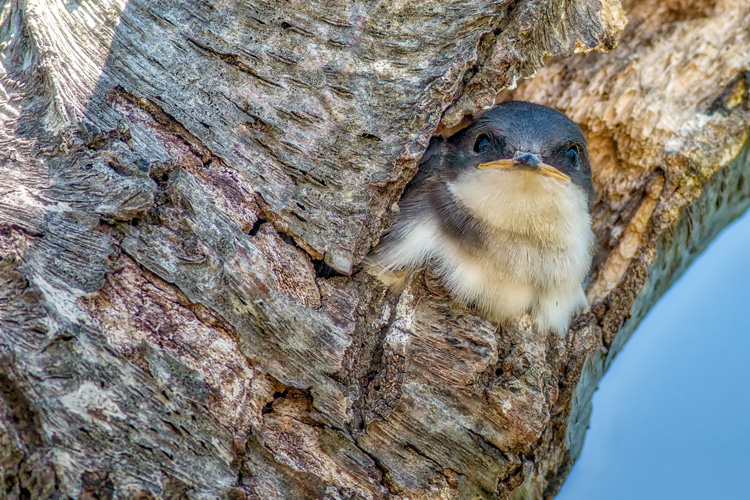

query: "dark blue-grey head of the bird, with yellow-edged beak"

left=445, top=101, right=594, bottom=203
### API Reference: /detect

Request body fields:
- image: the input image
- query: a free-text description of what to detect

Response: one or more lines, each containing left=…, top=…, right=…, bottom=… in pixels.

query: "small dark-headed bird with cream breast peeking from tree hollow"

left=363, top=101, right=596, bottom=336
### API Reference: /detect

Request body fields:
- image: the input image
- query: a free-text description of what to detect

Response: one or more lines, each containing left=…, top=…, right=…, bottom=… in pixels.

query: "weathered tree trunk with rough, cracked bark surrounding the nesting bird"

left=0, top=0, right=750, bottom=500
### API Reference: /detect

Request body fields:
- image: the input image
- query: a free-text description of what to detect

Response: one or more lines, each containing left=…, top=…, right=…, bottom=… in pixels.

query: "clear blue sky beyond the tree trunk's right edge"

left=556, top=208, right=750, bottom=500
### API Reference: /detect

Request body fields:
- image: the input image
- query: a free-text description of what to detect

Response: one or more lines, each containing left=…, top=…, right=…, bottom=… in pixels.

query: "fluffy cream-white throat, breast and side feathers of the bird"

left=366, top=171, right=594, bottom=334
